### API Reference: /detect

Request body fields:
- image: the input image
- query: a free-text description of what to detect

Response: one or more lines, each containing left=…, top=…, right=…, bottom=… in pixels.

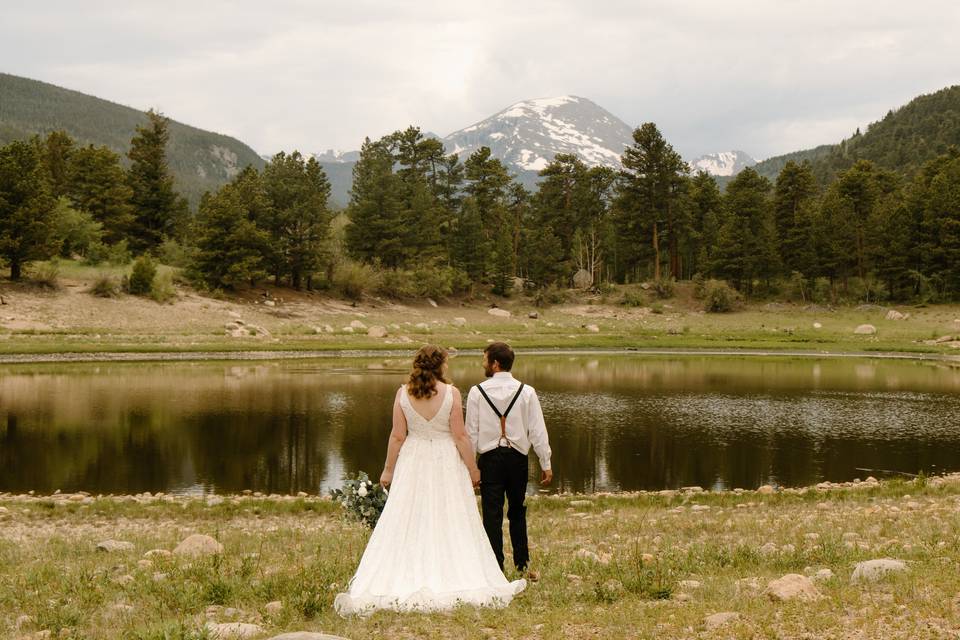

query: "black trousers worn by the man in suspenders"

left=477, top=447, right=530, bottom=571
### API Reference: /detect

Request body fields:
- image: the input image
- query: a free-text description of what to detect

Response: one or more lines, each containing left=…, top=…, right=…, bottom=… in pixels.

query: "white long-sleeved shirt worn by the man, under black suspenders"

left=466, top=371, right=550, bottom=471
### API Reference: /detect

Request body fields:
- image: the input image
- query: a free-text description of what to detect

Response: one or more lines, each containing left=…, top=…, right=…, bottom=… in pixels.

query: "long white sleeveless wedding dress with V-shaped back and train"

left=334, top=385, right=527, bottom=616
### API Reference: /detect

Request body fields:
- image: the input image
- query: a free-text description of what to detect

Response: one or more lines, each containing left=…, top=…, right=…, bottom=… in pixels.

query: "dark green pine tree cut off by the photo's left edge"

left=0, top=140, right=58, bottom=280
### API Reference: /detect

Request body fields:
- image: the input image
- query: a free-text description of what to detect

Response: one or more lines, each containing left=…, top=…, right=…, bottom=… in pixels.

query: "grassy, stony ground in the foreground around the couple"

left=0, top=475, right=960, bottom=639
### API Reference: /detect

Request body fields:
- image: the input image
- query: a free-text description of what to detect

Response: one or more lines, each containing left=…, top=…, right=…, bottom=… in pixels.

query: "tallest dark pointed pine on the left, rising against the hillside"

left=127, top=110, right=187, bottom=250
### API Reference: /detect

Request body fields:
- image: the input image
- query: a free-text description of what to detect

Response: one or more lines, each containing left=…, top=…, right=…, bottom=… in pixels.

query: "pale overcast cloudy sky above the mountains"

left=0, top=0, right=960, bottom=158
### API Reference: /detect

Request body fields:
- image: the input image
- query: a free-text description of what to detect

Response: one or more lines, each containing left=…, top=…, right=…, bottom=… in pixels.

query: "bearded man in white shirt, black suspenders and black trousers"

left=466, top=342, right=553, bottom=578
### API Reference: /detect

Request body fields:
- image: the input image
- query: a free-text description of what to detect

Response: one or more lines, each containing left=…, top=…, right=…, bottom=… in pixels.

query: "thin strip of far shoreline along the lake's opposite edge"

left=0, top=347, right=960, bottom=365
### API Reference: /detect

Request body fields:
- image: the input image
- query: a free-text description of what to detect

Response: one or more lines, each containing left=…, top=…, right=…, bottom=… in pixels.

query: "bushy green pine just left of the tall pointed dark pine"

left=67, top=145, right=134, bottom=244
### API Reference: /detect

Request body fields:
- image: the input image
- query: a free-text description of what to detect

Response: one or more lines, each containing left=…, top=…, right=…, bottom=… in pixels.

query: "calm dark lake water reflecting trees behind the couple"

left=0, top=355, right=960, bottom=493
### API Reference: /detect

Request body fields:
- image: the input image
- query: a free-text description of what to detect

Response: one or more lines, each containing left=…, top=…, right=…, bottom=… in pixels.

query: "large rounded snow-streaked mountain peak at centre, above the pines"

left=443, top=95, right=633, bottom=171
